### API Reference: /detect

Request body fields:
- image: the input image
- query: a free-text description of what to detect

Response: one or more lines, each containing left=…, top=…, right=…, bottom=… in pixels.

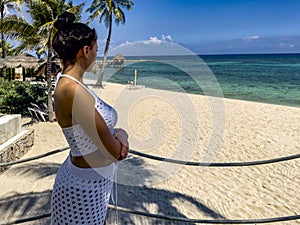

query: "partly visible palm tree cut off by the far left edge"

left=0, top=0, right=22, bottom=78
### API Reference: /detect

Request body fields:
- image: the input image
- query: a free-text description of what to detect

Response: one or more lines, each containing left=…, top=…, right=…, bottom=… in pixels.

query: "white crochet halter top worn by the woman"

left=56, top=74, right=118, bottom=156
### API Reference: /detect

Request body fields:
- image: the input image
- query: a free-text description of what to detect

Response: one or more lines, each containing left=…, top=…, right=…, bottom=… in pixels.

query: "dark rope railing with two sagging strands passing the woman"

left=0, top=147, right=300, bottom=225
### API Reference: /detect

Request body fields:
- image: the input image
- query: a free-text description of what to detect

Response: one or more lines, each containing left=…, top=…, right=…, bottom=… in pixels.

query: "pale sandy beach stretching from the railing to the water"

left=0, top=80, right=300, bottom=225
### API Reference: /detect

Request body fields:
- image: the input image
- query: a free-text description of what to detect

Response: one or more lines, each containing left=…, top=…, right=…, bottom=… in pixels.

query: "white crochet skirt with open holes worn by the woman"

left=51, top=157, right=115, bottom=225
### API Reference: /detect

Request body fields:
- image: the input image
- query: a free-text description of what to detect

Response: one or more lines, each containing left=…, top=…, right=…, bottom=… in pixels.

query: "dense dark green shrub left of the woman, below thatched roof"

left=0, top=81, right=47, bottom=115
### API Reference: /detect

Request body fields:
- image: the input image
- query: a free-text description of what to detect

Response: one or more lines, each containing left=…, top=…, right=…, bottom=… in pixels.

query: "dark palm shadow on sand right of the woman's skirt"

left=108, top=157, right=226, bottom=225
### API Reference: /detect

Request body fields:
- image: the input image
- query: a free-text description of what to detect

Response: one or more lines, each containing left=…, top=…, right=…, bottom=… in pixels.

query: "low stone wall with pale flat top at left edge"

left=0, top=130, right=34, bottom=172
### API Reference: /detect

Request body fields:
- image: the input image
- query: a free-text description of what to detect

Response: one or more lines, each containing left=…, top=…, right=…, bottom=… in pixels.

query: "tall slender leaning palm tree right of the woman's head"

left=86, top=0, right=134, bottom=88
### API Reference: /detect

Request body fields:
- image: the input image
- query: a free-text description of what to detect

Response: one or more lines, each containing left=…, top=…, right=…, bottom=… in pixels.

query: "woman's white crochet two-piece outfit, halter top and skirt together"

left=51, top=75, right=117, bottom=225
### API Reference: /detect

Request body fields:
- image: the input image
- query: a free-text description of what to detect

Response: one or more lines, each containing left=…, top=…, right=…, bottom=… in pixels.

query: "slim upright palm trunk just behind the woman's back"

left=45, top=44, right=54, bottom=122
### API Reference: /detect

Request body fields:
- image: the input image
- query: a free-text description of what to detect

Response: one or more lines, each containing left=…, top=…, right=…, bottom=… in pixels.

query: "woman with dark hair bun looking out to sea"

left=51, top=12, right=128, bottom=225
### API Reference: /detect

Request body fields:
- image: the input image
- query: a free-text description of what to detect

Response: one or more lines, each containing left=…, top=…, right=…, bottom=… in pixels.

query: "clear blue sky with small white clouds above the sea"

left=75, top=0, right=300, bottom=54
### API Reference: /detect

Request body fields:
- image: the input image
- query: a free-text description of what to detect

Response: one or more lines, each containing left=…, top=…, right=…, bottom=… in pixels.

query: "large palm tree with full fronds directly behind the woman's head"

left=4, top=0, right=84, bottom=122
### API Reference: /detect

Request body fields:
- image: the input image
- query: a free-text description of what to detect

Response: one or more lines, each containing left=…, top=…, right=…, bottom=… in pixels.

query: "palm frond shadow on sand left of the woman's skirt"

left=0, top=163, right=60, bottom=225
